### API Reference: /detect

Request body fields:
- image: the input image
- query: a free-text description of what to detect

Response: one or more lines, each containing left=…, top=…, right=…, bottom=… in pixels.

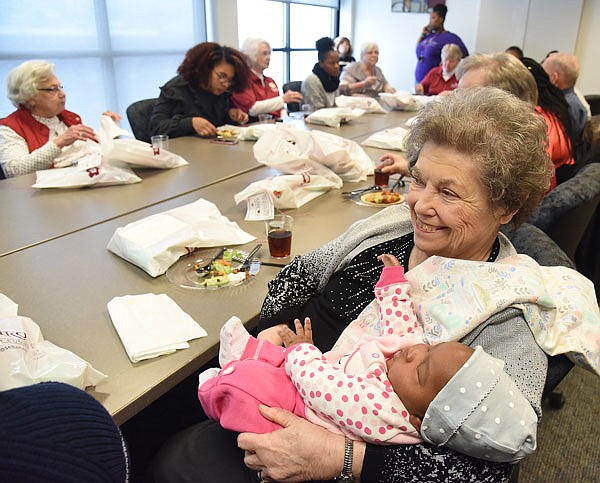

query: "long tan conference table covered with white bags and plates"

left=0, top=108, right=412, bottom=424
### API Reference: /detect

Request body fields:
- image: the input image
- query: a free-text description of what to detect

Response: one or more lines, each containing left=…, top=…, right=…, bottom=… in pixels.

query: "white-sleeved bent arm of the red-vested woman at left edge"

left=0, top=126, right=62, bottom=178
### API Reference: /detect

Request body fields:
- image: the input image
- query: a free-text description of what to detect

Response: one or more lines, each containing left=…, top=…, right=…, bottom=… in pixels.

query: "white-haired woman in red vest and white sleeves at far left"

left=0, top=60, right=121, bottom=177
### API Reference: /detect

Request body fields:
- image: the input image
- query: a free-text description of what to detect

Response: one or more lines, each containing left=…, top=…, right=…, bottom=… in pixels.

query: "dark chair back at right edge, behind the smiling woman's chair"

left=527, top=163, right=600, bottom=263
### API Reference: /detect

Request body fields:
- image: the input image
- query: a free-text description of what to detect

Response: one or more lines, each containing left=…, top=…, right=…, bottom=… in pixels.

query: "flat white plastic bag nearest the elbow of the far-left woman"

left=33, top=152, right=142, bottom=188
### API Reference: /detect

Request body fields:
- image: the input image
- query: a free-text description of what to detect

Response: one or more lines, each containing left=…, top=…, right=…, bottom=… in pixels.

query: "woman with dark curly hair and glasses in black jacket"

left=150, top=42, right=251, bottom=137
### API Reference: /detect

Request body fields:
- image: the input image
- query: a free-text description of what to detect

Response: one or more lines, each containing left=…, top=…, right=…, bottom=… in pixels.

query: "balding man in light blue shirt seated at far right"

left=542, top=52, right=587, bottom=137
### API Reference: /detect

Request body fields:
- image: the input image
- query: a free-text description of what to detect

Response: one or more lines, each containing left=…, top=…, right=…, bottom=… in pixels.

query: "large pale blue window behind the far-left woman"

left=0, top=0, right=206, bottom=128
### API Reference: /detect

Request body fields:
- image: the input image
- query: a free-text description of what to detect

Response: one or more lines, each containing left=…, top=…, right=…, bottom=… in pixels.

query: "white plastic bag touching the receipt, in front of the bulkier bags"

left=234, top=173, right=336, bottom=210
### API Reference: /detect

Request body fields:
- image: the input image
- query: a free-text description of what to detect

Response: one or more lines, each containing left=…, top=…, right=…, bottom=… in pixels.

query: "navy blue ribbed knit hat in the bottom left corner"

left=0, top=382, right=129, bottom=483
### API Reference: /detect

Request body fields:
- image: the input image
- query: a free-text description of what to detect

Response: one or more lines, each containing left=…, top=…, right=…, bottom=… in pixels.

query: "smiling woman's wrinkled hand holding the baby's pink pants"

left=238, top=405, right=365, bottom=482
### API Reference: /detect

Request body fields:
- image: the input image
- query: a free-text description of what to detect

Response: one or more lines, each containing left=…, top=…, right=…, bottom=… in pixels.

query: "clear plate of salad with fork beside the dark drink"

left=167, top=247, right=260, bottom=290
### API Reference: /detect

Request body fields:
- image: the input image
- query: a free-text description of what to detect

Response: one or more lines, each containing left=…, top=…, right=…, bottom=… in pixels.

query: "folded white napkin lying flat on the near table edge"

left=107, top=294, right=207, bottom=362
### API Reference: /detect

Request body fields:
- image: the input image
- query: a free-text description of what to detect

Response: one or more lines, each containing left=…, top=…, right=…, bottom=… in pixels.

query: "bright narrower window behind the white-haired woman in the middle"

left=237, top=0, right=339, bottom=88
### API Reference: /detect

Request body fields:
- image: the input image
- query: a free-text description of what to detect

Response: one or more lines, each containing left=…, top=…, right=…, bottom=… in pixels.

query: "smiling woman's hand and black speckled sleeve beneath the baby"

left=238, top=407, right=511, bottom=483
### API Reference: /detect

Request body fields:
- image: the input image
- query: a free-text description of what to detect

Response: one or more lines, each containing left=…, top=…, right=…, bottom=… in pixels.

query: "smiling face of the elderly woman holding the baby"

left=407, top=142, right=511, bottom=261
